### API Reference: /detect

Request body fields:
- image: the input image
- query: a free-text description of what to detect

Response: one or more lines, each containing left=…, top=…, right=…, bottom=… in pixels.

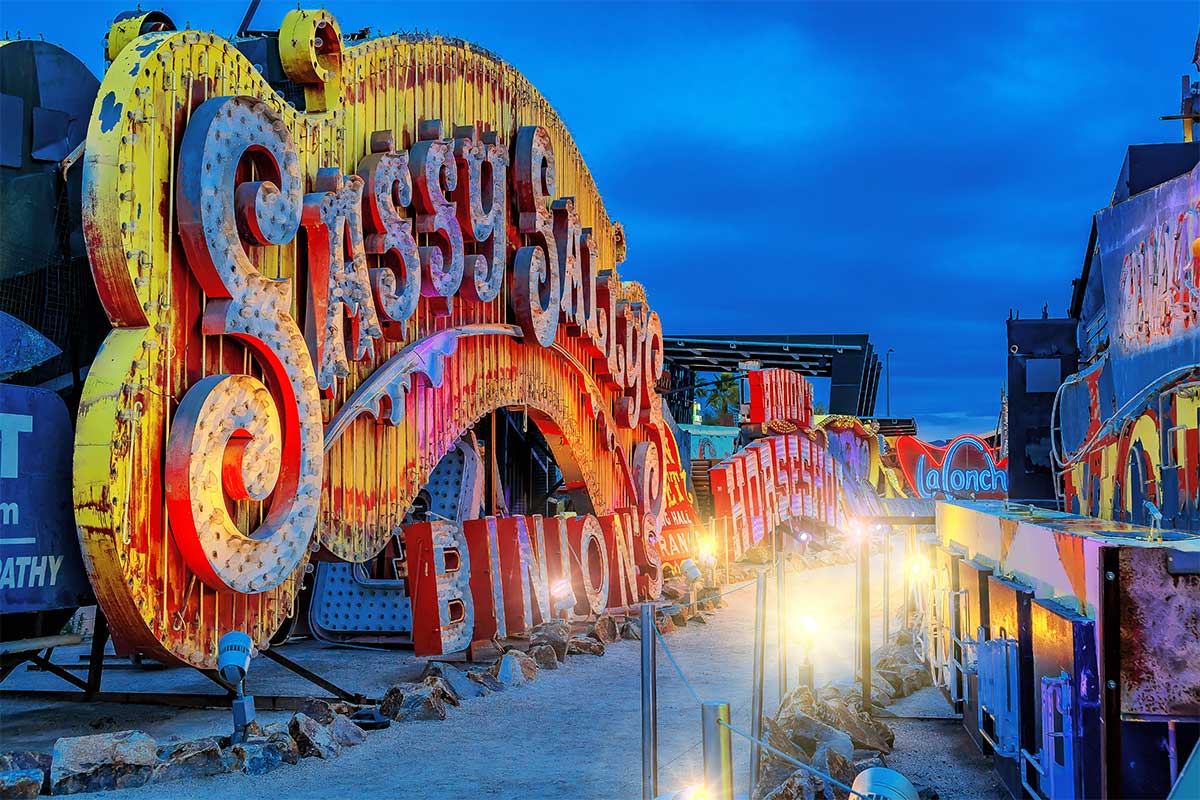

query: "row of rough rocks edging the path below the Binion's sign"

left=0, top=581, right=725, bottom=798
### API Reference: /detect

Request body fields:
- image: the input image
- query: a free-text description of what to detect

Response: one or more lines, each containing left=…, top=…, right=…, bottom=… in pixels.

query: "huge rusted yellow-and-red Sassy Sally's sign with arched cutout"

left=74, top=11, right=670, bottom=667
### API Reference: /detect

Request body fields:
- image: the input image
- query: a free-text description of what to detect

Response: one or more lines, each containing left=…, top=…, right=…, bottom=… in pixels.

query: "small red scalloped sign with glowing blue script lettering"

left=896, top=434, right=1008, bottom=500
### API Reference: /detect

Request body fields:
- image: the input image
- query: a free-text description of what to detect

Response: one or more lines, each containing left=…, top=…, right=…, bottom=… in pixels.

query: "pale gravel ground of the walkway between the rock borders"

left=0, top=551, right=992, bottom=800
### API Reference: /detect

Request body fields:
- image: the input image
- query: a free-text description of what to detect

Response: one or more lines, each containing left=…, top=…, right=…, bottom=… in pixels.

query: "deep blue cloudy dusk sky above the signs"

left=0, top=0, right=1200, bottom=439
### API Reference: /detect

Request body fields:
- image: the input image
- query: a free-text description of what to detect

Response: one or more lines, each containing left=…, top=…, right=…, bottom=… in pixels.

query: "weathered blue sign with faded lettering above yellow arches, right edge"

left=1052, top=160, right=1200, bottom=531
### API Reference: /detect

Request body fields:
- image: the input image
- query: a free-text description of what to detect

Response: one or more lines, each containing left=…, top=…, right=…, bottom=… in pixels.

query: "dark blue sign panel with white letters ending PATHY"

left=0, top=384, right=95, bottom=614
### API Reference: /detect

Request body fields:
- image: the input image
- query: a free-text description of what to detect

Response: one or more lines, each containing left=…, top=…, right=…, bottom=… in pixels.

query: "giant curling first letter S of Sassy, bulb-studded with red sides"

left=166, top=97, right=324, bottom=594
